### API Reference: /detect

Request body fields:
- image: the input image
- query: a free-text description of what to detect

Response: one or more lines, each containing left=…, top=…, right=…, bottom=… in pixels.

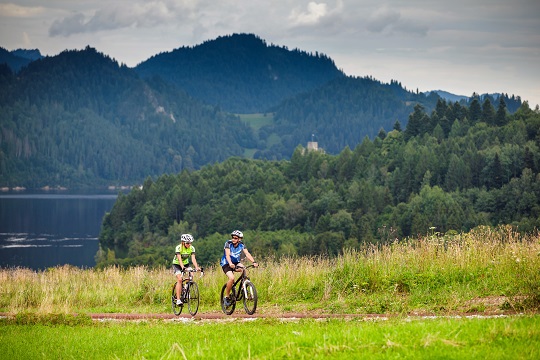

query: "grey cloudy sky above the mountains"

left=0, top=0, right=540, bottom=108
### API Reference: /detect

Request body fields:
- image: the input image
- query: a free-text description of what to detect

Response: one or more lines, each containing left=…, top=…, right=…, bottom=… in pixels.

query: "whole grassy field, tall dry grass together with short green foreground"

left=0, top=227, right=540, bottom=359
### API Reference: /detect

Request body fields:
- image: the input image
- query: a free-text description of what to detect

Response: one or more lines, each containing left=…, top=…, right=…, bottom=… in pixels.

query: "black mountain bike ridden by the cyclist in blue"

left=220, top=265, right=258, bottom=315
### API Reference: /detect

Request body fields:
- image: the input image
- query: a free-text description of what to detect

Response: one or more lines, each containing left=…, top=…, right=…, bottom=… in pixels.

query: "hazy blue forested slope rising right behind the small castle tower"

left=255, top=77, right=439, bottom=159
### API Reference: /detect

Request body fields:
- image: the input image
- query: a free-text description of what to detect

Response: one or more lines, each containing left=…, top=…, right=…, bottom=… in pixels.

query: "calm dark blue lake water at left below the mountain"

left=0, top=192, right=117, bottom=270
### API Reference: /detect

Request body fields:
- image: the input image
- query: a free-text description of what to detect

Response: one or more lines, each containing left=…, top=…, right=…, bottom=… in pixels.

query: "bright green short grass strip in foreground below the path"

left=0, top=315, right=540, bottom=359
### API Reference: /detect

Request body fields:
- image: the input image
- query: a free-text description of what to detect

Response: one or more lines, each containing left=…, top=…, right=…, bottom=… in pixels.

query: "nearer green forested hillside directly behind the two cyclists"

left=97, top=100, right=540, bottom=266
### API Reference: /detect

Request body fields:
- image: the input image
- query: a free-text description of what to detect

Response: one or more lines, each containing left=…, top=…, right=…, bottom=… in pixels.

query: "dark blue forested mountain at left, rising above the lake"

left=0, top=48, right=254, bottom=188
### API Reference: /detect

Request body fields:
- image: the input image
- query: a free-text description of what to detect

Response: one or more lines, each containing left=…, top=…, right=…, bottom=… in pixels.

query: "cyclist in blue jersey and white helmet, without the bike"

left=219, top=230, right=259, bottom=306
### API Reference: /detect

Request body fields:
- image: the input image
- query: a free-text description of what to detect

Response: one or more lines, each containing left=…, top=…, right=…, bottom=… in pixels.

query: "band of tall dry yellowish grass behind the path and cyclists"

left=0, top=227, right=540, bottom=313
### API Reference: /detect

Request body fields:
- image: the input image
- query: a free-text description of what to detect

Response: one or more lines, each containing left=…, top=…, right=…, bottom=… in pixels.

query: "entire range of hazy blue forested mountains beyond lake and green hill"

left=0, top=34, right=521, bottom=191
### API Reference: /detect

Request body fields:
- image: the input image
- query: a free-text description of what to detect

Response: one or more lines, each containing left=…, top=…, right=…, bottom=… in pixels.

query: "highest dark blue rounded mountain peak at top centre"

left=135, top=34, right=345, bottom=113
